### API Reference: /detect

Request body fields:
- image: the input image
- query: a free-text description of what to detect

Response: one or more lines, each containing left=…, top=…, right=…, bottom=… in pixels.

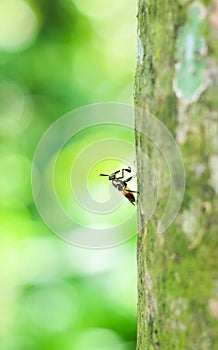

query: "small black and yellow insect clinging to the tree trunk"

left=100, top=167, right=139, bottom=205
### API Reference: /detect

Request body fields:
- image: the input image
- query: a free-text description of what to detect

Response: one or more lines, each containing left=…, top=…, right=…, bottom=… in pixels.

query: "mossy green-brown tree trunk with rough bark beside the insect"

left=135, top=0, right=218, bottom=350
